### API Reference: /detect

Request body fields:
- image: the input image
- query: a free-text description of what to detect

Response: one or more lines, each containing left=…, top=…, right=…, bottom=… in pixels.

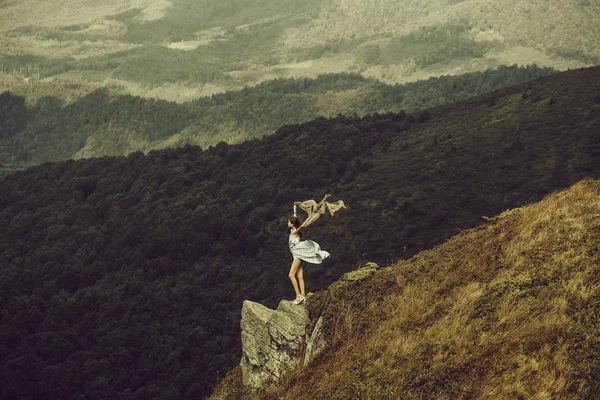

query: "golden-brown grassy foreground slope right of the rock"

left=213, top=180, right=600, bottom=400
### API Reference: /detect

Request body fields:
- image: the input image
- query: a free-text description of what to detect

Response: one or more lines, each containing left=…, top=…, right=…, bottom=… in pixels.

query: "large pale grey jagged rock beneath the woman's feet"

left=240, top=300, right=325, bottom=390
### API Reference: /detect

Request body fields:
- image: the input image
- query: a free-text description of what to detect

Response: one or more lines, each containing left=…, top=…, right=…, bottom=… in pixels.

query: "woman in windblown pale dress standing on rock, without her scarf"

left=288, top=204, right=329, bottom=304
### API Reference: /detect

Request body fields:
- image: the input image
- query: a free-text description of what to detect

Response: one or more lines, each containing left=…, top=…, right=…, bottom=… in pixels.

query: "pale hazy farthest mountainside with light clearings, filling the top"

left=0, top=0, right=600, bottom=101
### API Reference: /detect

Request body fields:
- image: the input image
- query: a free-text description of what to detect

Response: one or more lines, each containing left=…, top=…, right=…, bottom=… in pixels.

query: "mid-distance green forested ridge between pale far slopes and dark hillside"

left=0, top=66, right=553, bottom=169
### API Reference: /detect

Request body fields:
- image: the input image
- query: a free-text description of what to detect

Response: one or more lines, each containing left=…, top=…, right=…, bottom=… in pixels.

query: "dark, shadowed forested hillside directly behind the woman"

left=0, top=68, right=600, bottom=399
